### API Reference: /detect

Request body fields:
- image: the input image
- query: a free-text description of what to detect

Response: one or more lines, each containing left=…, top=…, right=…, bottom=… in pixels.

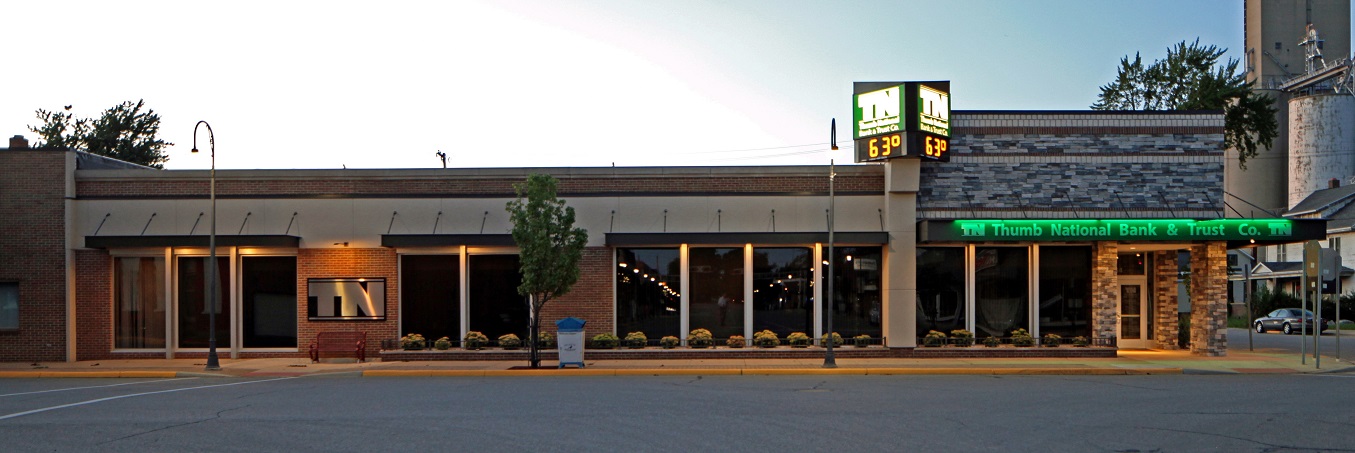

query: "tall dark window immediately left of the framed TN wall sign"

left=240, top=256, right=297, bottom=347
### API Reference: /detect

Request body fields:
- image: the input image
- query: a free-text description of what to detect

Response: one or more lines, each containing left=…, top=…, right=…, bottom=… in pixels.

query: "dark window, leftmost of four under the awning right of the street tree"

left=617, top=248, right=686, bottom=338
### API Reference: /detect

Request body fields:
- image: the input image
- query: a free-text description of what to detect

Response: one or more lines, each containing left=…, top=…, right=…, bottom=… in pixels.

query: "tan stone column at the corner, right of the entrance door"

left=1190, top=241, right=1228, bottom=357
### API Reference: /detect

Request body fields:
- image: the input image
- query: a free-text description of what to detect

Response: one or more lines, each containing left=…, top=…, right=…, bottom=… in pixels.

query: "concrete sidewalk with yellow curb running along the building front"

left=0, top=350, right=1355, bottom=377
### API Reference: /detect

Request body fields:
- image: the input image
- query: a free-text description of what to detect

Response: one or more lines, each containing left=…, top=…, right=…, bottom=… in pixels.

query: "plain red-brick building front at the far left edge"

left=0, top=149, right=69, bottom=362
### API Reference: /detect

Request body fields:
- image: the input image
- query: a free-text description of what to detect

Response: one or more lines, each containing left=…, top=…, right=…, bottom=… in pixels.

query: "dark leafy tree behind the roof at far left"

left=28, top=99, right=173, bottom=168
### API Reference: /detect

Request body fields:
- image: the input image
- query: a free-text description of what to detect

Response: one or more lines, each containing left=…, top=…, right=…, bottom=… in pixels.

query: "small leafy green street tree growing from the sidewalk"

left=507, top=175, right=588, bottom=368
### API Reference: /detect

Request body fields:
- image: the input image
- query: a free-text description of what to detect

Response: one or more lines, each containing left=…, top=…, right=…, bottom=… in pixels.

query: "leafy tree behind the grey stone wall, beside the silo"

left=1092, top=39, right=1279, bottom=170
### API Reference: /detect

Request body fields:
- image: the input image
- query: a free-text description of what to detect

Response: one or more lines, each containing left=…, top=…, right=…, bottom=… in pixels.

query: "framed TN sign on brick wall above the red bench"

left=306, top=278, right=386, bottom=321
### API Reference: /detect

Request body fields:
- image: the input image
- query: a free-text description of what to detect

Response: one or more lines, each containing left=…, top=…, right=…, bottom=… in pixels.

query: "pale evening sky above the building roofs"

left=0, top=0, right=1344, bottom=170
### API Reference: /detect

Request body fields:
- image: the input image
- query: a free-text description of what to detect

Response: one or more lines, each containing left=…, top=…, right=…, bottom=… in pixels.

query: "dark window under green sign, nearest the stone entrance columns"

left=1037, top=247, right=1092, bottom=338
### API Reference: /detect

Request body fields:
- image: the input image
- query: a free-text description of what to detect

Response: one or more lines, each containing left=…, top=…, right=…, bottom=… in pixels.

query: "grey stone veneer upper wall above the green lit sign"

left=917, top=111, right=1224, bottom=218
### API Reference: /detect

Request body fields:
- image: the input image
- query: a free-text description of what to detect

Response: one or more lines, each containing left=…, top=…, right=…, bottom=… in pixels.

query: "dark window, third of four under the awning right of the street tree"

left=753, top=247, right=814, bottom=336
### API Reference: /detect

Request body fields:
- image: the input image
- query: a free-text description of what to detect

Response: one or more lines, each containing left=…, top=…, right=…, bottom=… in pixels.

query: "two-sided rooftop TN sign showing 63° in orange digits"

left=852, top=81, right=950, bottom=161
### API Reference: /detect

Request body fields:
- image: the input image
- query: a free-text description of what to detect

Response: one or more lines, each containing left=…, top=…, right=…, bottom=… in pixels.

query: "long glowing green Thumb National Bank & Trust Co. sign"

left=924, top=218, right=1327, bottom=241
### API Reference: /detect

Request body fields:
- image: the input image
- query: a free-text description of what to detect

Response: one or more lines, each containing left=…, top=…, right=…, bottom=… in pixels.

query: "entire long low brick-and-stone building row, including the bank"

left=0, top=111, right=1324, bottom=361
